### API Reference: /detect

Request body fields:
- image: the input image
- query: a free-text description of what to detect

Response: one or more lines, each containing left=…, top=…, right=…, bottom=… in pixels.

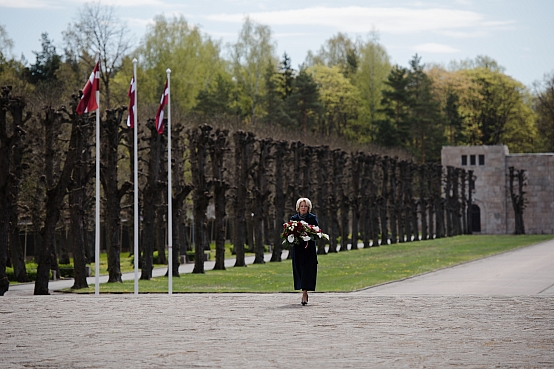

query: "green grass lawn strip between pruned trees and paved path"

left=65, top=235, right=554, bottom=293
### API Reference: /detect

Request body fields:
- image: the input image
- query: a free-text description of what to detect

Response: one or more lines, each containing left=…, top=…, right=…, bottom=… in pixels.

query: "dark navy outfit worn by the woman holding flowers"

left=290, top=213, right=319, bottom=291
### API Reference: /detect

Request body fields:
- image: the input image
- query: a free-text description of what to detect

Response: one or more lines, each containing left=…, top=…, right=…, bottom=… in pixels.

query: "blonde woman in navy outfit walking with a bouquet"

left=290, top=197, right=319, bottom=305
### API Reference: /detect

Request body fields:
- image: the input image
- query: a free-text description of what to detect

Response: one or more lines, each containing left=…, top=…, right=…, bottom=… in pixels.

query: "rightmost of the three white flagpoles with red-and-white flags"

left=164, top=68, right=173, bottom=295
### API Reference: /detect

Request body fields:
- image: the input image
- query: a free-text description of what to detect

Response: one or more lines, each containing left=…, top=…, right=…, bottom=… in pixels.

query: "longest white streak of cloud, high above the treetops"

left=207, top=6, right=496, bottom=34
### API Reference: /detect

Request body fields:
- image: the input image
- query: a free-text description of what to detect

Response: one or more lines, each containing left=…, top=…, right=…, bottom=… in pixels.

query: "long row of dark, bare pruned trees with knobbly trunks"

left=0, top=89, right=486, bottom=294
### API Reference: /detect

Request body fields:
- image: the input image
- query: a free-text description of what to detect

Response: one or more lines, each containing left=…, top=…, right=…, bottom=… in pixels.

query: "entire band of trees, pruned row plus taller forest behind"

left=0, top=4, right=554, bottom=294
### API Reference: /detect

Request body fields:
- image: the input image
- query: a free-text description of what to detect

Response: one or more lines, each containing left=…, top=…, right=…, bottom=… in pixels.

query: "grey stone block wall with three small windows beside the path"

left=441, top=145, right=554, bottom=234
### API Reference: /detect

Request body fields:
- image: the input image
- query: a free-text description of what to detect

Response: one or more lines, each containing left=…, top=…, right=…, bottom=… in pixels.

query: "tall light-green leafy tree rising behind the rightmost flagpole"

left=129, top=15, right=227, bottom=111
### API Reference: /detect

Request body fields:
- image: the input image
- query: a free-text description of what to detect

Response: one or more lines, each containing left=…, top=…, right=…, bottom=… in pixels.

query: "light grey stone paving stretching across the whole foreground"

left=0, top=293, right=554, bottom=368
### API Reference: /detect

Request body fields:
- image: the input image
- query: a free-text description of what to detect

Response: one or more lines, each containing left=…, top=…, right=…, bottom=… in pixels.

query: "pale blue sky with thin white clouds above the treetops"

left=0, top=0, right=554, bottom=86
